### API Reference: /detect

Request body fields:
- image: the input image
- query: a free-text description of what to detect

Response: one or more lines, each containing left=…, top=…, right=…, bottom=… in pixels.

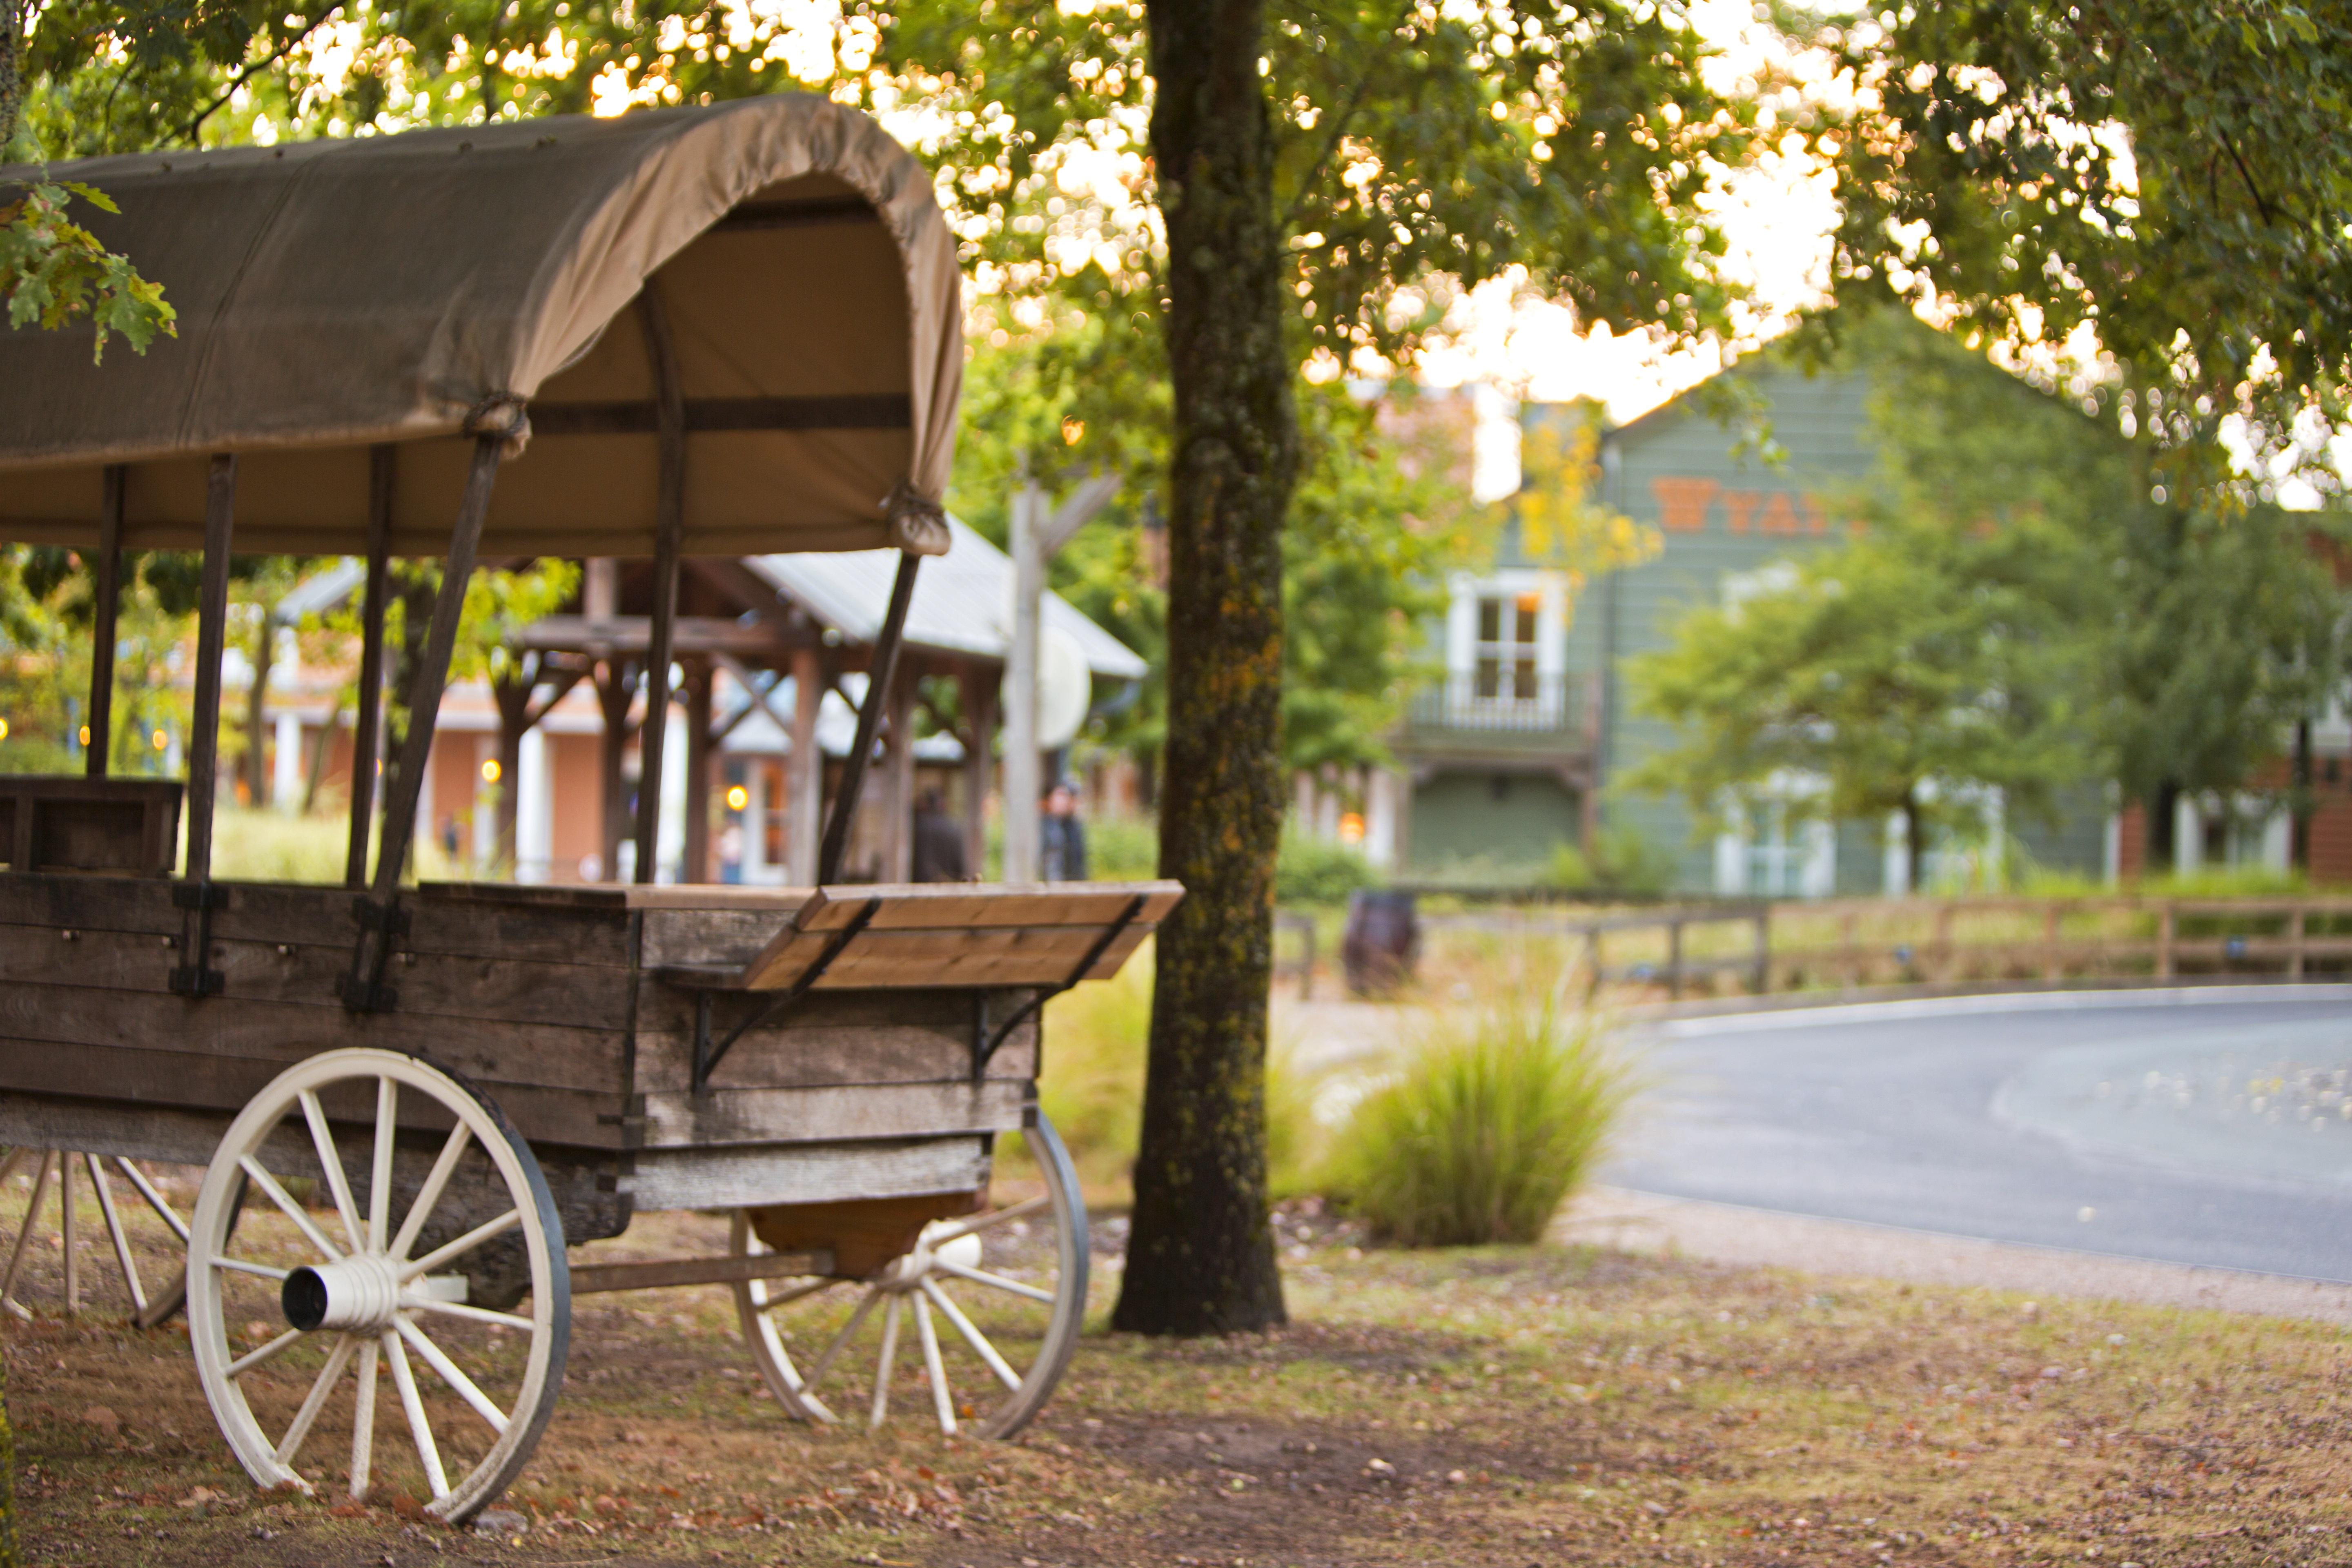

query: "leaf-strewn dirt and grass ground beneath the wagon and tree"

left=0, top=1201, right=2352, bottom=1568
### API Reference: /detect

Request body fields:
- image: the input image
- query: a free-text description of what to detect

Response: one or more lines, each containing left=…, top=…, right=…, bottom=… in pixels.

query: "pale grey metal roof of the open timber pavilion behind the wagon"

left=743, top=517, right=1150, bottom=679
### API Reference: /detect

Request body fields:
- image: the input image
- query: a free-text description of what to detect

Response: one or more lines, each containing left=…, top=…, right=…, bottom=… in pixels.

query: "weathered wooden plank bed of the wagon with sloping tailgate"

left=0, top=875, right=1181, bottom=1239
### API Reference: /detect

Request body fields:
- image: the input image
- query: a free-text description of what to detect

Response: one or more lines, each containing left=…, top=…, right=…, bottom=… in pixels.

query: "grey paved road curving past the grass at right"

left=1602, top=985, right=2352, bottom=1281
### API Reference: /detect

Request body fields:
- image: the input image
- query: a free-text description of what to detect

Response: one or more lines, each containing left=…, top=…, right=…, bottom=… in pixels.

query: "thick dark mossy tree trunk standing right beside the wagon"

left=1110, top=0, right=1298, bottom=1333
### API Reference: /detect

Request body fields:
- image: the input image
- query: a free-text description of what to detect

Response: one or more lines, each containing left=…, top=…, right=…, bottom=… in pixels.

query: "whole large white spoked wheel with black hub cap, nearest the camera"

left=188, top=1049, right=572, bottom=1523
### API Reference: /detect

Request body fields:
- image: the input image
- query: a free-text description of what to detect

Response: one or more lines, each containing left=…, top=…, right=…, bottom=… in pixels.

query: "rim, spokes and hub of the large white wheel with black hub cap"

left=188, top=1049, right=572, bottom=1523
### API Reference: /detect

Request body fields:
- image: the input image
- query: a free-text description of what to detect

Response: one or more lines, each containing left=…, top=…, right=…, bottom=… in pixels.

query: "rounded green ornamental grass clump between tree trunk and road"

left=1331, top=994, right=1632, bottom=1246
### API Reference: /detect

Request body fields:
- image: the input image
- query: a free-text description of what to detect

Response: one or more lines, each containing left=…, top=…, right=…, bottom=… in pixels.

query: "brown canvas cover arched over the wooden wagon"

left=0, top=94, right=962, bottom=555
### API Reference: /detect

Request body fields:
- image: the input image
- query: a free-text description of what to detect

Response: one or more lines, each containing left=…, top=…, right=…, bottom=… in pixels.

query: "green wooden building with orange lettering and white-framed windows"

left=1371, top=327, right=2117, bottom=895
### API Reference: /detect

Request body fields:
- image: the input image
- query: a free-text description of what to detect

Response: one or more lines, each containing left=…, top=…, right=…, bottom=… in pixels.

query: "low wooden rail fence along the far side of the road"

left=1423, top=898, right=2352, bottom=997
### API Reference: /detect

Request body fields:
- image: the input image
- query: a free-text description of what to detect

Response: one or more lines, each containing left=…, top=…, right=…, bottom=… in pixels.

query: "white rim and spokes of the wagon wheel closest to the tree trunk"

left=729, top=1114, right=1087, bottom=1437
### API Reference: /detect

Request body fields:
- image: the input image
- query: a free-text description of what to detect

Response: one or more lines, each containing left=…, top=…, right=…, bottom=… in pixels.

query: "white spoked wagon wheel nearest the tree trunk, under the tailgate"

left=731, top=1117, right=1087, bottom=1437
